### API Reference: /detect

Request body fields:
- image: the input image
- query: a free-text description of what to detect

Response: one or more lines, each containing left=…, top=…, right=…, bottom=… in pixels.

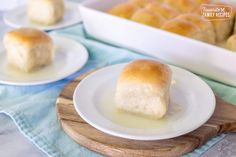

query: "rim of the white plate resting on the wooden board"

left=73, top=63, right=216, bottom=141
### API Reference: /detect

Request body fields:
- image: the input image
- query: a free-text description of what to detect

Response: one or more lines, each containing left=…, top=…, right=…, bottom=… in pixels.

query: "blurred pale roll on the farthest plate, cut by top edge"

left=28, top=0, right=65, bottom=25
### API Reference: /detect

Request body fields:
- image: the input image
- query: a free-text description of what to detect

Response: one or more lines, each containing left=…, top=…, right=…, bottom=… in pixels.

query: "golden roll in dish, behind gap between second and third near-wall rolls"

left=146, top=2, right=179, bottom=19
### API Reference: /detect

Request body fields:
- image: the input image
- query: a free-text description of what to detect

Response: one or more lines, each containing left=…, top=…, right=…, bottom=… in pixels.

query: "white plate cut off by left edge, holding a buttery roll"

left=0, top=35, right=88, bottom=86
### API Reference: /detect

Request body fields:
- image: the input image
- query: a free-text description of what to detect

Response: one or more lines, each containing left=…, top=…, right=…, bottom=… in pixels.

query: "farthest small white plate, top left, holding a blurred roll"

left=3, top=2, right=81, bottom=31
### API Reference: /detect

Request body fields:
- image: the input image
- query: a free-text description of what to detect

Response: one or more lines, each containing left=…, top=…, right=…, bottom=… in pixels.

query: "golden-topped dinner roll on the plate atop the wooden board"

left=115, top=59, right=172, bottom=119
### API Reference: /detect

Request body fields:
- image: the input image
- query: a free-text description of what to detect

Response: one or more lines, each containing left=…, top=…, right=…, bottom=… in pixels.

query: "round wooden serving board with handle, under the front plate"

left=56, top=72, right=236, bottom=157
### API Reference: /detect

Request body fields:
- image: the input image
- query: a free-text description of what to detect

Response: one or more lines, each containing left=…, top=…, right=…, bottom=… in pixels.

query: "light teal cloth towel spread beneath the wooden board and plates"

left=0, top=25, right=236, bottom=157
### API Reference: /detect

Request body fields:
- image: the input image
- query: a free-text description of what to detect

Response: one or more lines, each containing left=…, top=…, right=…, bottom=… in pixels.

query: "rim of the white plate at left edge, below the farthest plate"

left=0, top=34, right=89, bottom=86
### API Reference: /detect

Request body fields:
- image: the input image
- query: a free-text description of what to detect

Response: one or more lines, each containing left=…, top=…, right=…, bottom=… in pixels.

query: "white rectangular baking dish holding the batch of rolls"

left=79, top=0, right=236, bottom=86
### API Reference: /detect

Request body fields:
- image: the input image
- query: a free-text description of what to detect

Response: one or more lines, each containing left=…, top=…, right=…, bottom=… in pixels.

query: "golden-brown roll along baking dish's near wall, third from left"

left=161, top=19, right=203, bottom=40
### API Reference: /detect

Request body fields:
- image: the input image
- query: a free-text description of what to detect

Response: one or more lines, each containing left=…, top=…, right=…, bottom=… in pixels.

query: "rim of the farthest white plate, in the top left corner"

left=3, top=1, right=82, bottom=31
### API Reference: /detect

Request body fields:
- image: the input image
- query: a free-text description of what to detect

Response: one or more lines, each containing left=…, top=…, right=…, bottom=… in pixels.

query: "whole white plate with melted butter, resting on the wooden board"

left=73, top=64, right=215, bottom=140
